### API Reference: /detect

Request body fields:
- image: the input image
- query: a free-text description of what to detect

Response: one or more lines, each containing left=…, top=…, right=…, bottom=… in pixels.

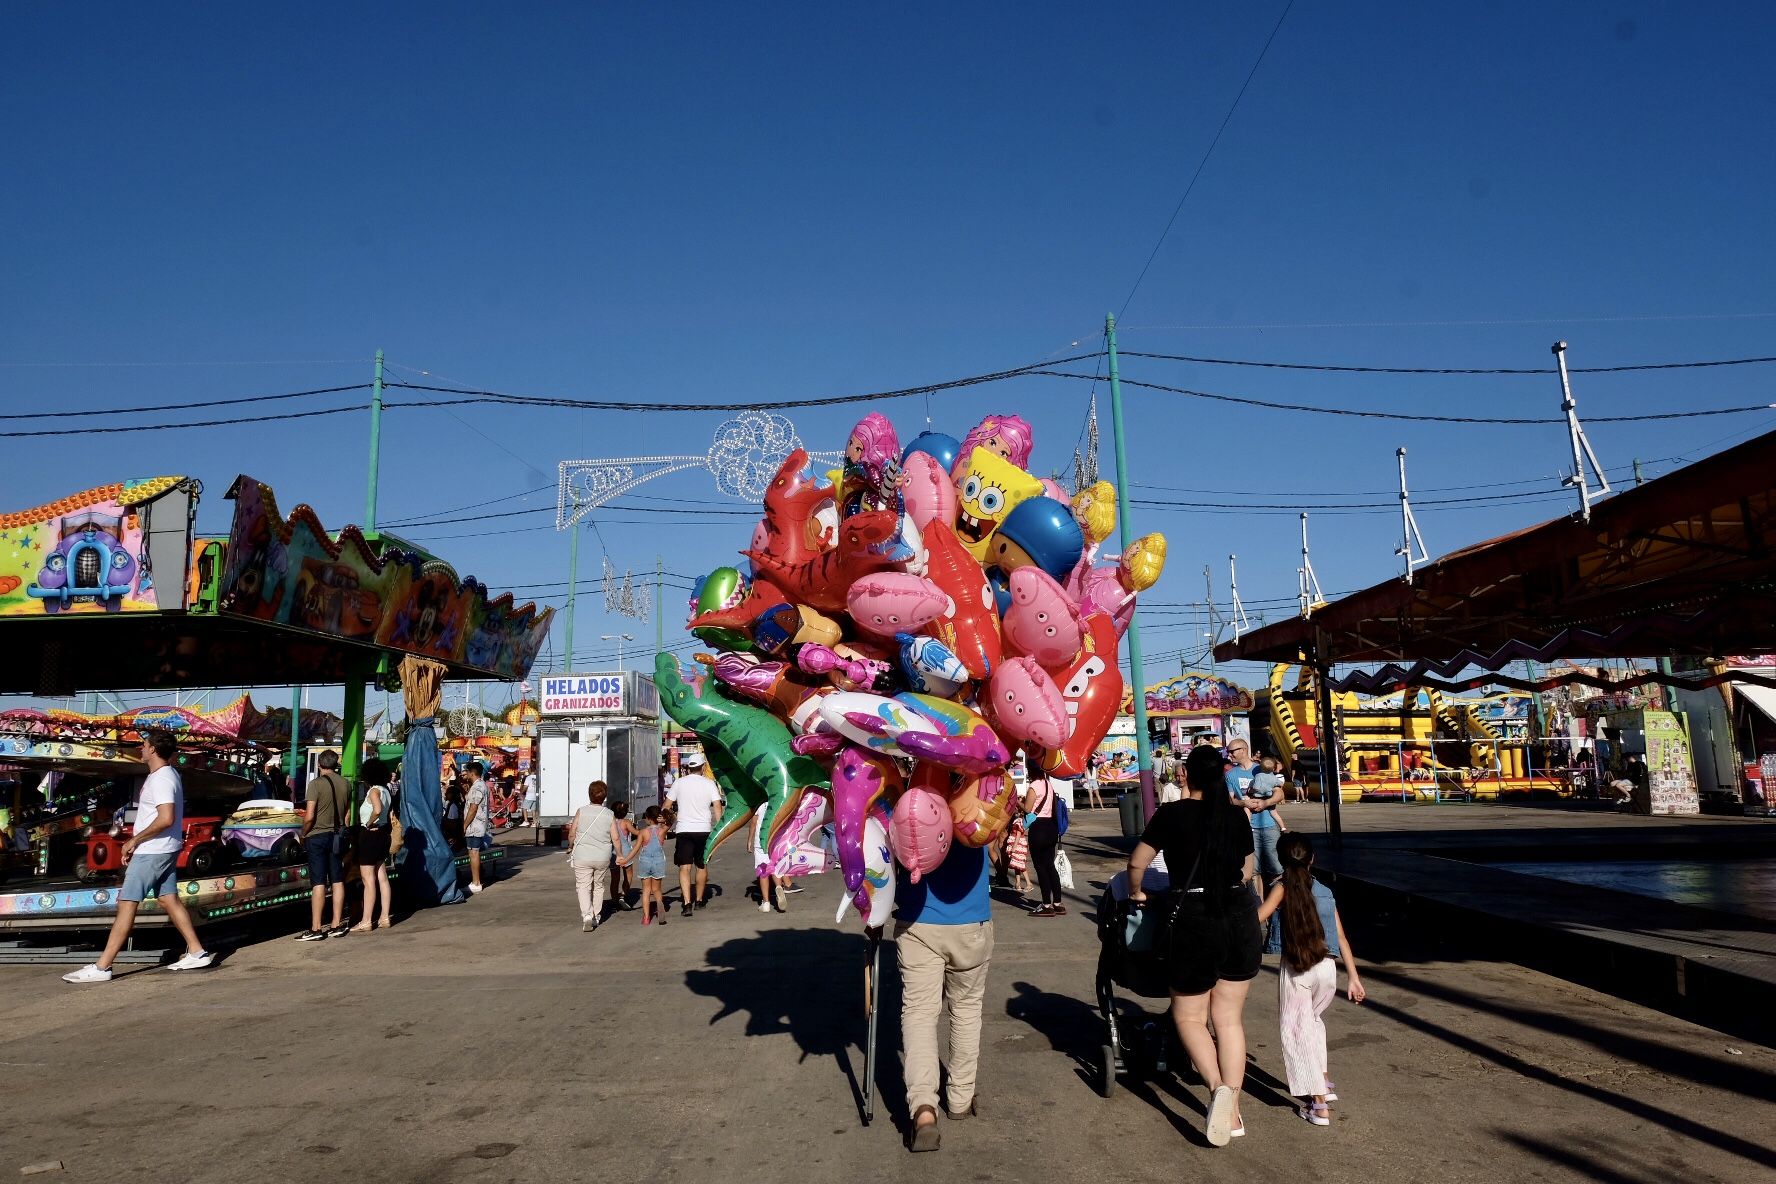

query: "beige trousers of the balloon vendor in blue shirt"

left=895, top=921, right=993, bottom=1115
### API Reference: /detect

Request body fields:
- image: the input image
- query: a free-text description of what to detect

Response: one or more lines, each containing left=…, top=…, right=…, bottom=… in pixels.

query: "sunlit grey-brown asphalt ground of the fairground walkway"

left=0, top=811, right=1776, bottom=1184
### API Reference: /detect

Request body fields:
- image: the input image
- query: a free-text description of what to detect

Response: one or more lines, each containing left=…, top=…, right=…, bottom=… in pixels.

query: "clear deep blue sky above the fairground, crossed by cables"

left=0, top=0, right=1776, bottom=713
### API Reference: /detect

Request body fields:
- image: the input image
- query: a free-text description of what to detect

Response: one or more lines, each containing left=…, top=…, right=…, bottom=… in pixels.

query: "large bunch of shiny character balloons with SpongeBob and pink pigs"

left=655, top=414, right=1165, bottom=927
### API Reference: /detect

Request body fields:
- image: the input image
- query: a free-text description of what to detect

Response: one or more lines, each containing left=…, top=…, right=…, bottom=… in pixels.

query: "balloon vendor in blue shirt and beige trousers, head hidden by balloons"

left=893, top=843, right=993, bottom=1150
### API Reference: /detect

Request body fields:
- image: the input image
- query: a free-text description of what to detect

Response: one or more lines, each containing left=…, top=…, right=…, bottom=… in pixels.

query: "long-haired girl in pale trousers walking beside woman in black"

left=1257, top=834, right=1368, bottom=1127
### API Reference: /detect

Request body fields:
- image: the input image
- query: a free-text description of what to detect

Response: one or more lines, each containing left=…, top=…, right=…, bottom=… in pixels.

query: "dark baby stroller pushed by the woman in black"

left=1098, top=868, right=1177, bottom=1097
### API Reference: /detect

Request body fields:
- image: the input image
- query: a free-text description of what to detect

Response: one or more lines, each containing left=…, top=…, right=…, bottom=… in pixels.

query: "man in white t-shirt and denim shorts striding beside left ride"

left=62, top=730, right=215, bottom=983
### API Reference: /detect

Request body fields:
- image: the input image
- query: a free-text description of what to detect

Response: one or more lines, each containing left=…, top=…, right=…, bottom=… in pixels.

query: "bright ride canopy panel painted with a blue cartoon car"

left=0, top=478, right=195, bottom=616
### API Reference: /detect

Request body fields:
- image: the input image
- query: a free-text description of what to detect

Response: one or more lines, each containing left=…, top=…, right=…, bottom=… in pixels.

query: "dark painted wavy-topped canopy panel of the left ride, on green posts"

left=217, top=478, right=554, bottom=680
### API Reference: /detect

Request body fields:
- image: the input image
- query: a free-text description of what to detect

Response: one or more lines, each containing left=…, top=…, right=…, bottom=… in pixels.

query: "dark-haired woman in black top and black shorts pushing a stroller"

left=1128, top=746, right=1265, bottom=1147
